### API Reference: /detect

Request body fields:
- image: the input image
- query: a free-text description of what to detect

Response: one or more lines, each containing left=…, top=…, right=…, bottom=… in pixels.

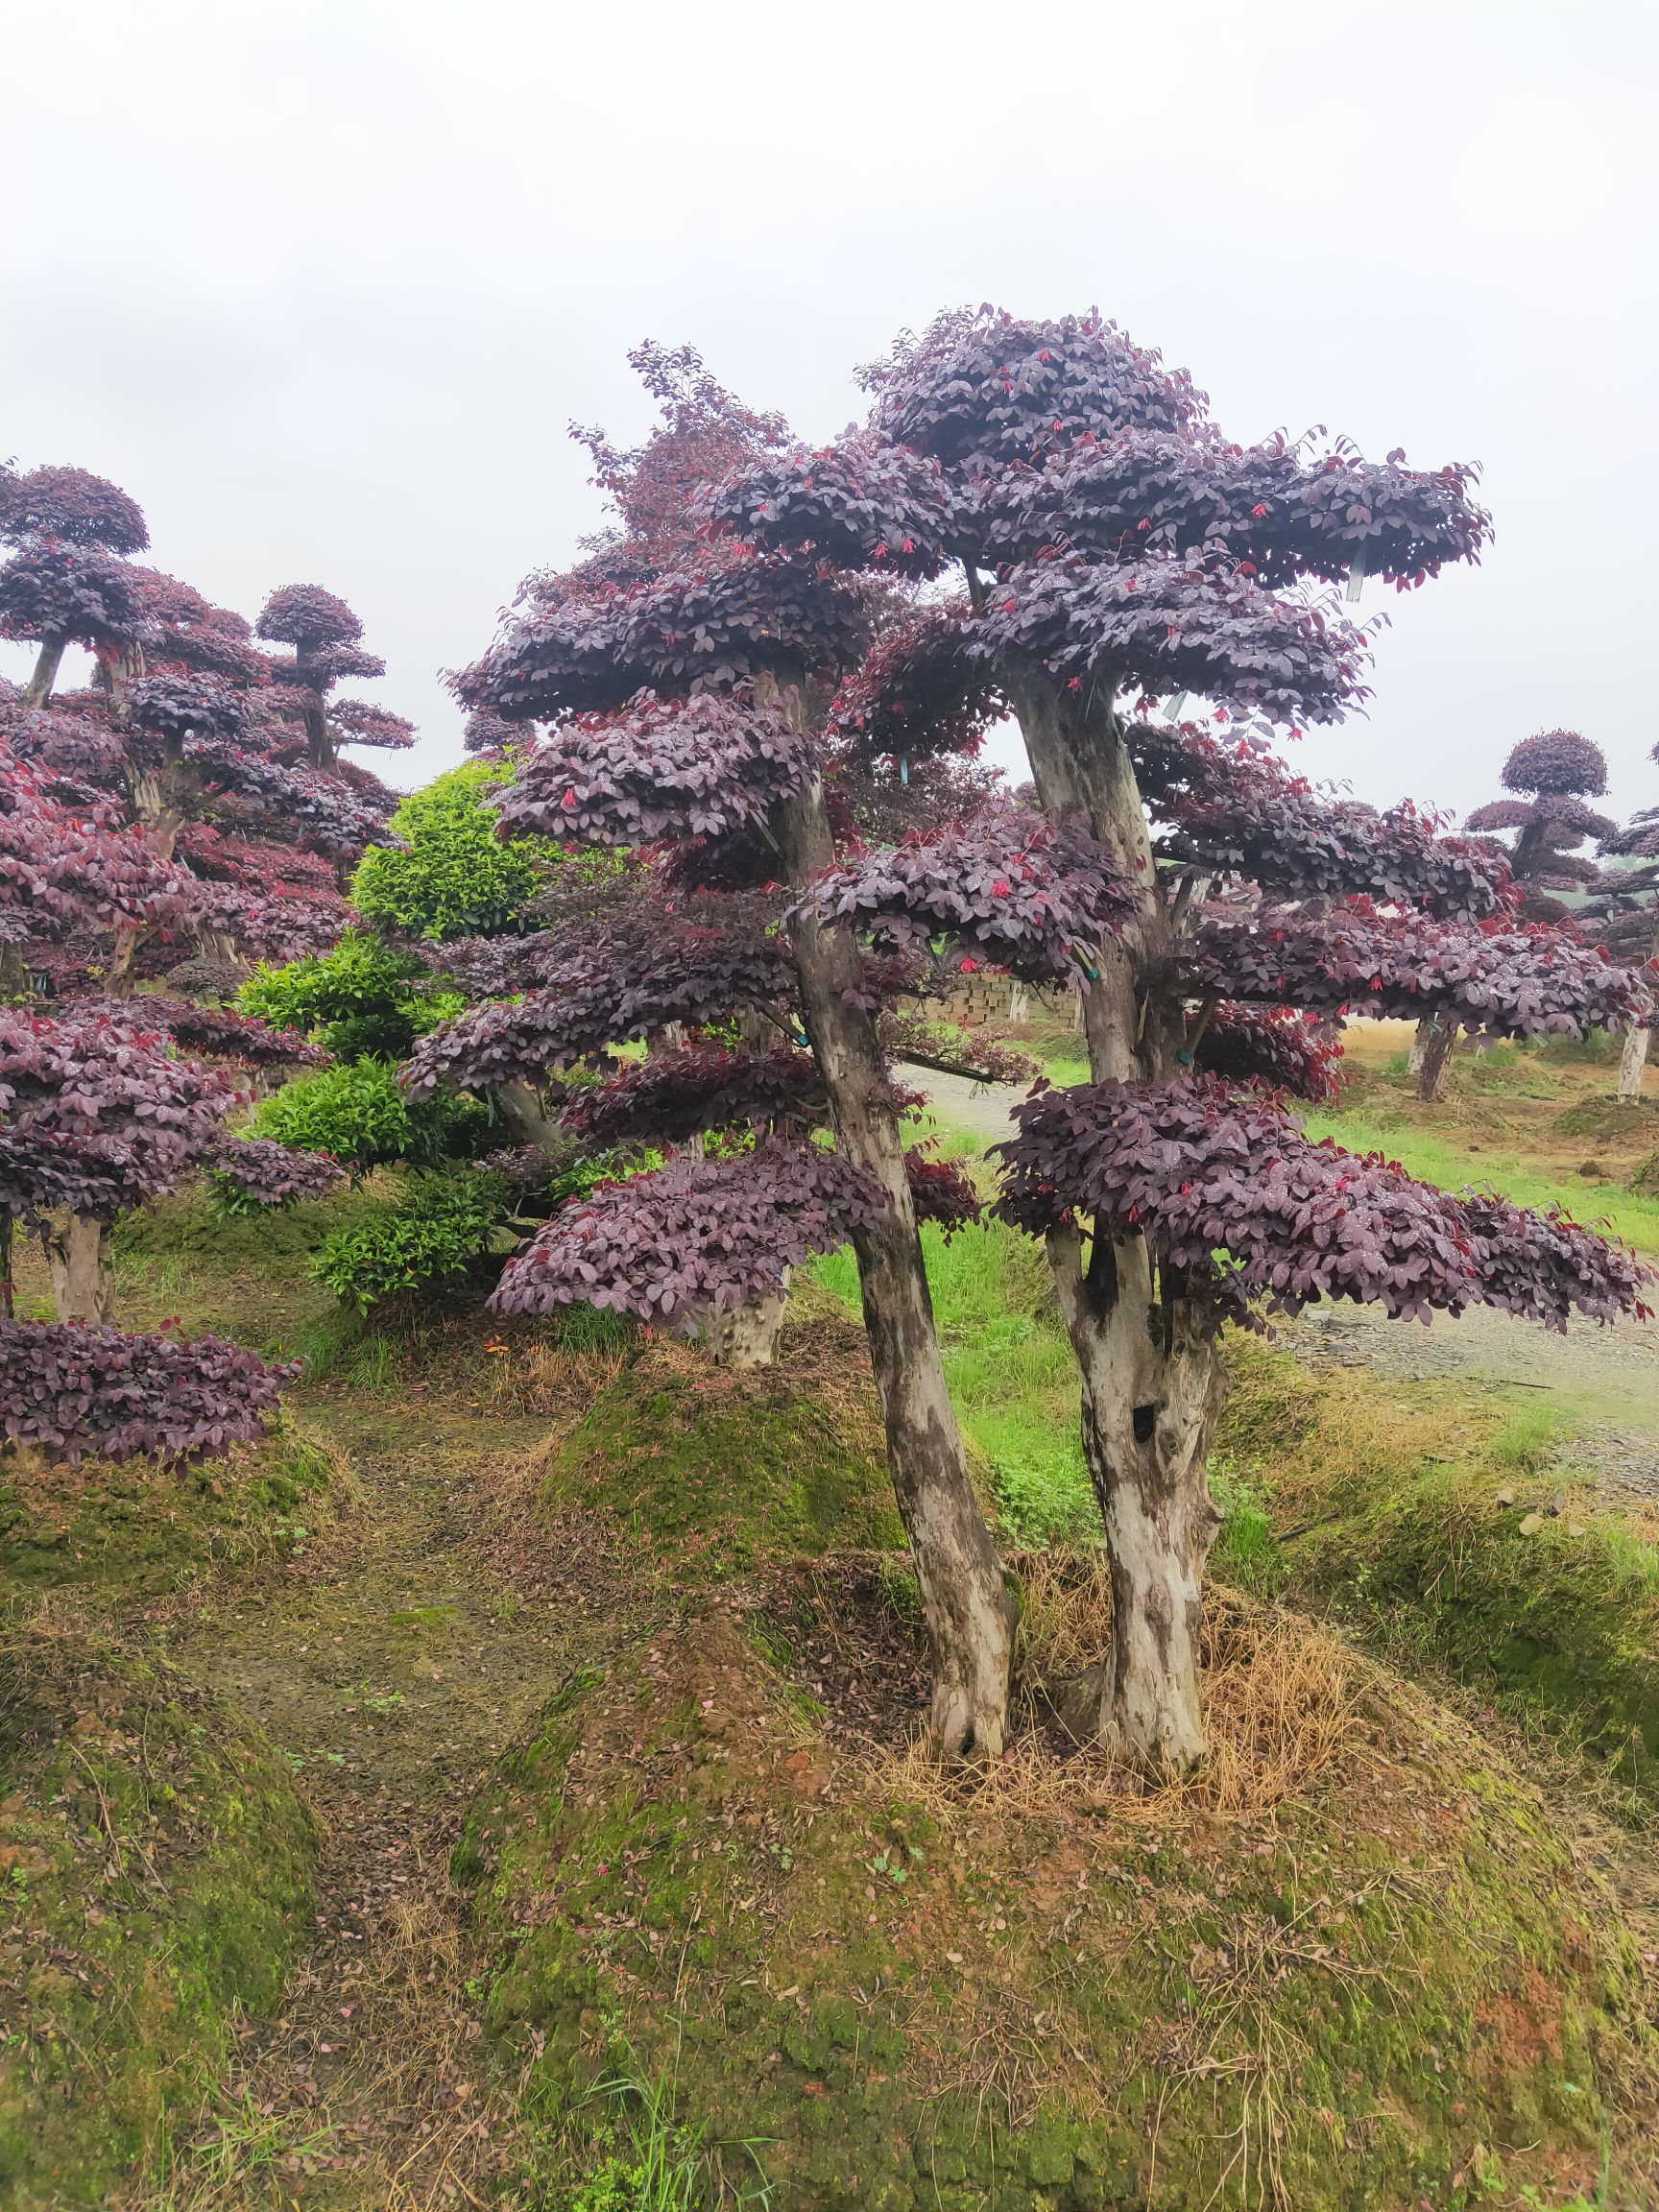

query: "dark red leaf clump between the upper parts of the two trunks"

left=830, top=599, right=1004, bottom=761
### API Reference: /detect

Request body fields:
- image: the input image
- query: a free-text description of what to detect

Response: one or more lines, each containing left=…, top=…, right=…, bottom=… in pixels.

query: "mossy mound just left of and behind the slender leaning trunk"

left=544, top=1320, right=902, bottom=1575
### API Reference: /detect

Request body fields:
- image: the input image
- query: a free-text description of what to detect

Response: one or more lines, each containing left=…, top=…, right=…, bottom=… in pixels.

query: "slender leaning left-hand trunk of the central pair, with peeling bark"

left=772, top=690, right=1013, bottom=1759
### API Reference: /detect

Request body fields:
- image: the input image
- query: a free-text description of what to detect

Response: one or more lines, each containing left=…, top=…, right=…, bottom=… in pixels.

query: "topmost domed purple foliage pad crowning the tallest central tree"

left=863, top=307, right=1203, bottom=465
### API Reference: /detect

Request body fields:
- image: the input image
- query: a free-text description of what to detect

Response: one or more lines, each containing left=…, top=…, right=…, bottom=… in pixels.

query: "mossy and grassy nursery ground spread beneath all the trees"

left=0, top=1050, right=1659, bottom=2212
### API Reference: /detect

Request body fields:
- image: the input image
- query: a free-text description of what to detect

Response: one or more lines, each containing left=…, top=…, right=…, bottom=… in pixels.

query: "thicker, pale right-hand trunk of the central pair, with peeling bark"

left=1013, top=688, right=1221, bottom=1774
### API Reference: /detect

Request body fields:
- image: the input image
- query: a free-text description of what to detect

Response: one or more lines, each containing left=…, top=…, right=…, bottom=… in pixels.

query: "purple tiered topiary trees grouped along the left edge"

left=0, top=467, right=414, bottom=1457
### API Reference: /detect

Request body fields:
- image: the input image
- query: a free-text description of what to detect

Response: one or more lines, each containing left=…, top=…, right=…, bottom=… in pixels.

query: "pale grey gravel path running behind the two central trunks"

left=907, top=1069, right=1659, bottom=1498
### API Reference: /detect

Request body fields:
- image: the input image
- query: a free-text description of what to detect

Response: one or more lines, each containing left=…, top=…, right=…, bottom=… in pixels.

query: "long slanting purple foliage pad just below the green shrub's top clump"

left=405, top=931, right=792, bottom=1097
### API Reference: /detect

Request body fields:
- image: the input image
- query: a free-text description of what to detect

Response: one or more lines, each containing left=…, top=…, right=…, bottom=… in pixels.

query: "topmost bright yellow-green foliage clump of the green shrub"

left=351, top=761, right=584, bottom=940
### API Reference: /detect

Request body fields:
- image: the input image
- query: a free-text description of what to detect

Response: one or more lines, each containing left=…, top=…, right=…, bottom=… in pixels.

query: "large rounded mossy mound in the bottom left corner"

left=0, top=1617, right=314, bottom=2212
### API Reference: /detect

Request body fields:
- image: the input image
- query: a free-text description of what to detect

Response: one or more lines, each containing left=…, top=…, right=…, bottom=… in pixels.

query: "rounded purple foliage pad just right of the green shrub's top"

left=495, top=690, right=812, bottom=845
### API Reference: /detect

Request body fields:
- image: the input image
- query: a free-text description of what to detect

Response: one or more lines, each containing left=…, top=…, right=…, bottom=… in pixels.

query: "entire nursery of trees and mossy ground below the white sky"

left=0, top=307, right=1659, bottom=2212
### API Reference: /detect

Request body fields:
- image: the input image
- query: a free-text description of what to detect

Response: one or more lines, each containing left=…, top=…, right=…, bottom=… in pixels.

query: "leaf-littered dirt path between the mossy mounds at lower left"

left=158, top=1394, right=617, bottom=2212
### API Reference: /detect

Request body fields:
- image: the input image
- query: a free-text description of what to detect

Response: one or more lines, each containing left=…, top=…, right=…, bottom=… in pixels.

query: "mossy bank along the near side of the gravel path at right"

left=1216, top=1345, right=1659, bottom=1796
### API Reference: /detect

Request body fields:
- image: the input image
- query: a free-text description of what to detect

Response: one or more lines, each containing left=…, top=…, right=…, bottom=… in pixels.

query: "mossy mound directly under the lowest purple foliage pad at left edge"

left=0, top=1420, right=345, bottom=1599
